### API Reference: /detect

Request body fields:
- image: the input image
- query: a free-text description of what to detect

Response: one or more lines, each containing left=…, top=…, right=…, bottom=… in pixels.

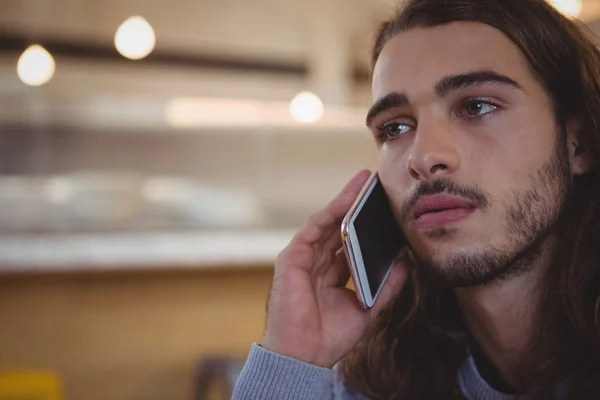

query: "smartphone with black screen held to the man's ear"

left=342, top=172, right=407, bottom=308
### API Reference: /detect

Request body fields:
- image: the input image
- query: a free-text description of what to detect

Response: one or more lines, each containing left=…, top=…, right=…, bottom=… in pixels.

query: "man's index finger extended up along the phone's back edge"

left=293, top=170, right=371, bottom=245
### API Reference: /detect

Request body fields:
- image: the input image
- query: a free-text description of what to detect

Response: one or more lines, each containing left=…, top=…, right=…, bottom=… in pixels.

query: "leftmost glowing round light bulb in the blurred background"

left=17, top=44, right=56, bottom=86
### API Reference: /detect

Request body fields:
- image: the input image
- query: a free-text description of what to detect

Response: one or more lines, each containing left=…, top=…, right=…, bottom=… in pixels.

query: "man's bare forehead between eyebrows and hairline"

left=372, top=21, right=534, bottom=99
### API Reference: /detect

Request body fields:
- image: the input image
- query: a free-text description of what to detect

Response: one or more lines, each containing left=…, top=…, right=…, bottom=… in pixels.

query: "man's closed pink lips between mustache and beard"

left=413, top=194, right=475, bottom=229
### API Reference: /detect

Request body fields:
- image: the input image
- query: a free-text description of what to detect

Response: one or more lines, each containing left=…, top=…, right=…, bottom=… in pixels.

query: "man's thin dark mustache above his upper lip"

left=402, top=178, right=490, bottom=219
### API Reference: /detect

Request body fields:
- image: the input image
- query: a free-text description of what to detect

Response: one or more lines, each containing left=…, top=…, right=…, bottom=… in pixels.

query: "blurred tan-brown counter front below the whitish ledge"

left=0, top=268, right=272, bottom=400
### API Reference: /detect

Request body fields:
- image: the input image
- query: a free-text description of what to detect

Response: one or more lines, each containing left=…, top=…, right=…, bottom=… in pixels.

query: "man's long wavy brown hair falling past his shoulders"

left=341, top=0, right=600, bottom=400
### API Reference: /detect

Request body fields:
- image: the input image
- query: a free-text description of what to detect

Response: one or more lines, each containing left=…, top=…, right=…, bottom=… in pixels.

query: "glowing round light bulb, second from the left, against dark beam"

left=115, top=16, right=156, bottom=60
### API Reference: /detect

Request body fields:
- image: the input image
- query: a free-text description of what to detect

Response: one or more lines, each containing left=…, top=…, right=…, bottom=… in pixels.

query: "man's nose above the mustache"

left=408, top=121, right=461, bottom=180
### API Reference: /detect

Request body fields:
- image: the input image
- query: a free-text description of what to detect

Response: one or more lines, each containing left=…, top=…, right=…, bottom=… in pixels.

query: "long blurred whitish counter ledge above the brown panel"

left=0, top=230, right=294, bottom=273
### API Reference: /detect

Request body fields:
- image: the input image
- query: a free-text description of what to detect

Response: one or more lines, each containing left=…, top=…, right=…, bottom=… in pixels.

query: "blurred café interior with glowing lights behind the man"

left=0, top=0, right=600, bottom=400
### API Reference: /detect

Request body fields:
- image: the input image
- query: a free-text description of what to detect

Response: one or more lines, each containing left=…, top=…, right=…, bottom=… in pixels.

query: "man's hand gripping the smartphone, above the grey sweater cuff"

left=262, top=171, right=409, bottom=368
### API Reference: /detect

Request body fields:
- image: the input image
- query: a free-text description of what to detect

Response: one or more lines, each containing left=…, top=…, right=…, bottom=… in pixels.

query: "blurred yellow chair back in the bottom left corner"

left=0, top=372, right=64, bottom=400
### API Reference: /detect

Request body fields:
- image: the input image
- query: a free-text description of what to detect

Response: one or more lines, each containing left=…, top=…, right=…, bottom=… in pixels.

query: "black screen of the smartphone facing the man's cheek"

left=354, top=179, right=406, bottom=296
